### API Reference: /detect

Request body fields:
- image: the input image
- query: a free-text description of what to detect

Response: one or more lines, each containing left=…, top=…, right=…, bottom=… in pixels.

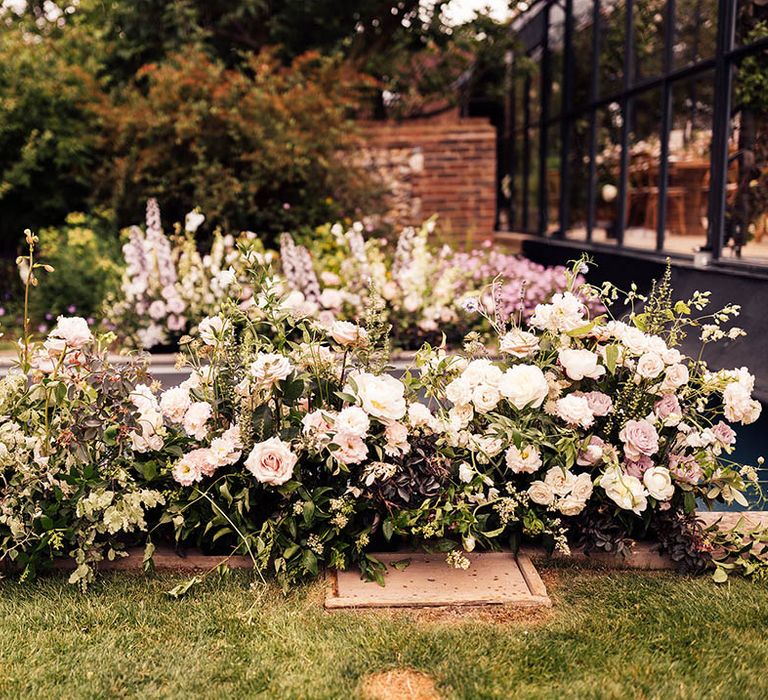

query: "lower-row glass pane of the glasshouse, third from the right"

left=624, top=89, right=662, bottom=249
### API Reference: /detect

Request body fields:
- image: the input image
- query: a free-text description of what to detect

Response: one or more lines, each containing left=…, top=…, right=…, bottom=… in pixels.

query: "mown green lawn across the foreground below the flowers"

left=0, top=567, right=768, bottom=698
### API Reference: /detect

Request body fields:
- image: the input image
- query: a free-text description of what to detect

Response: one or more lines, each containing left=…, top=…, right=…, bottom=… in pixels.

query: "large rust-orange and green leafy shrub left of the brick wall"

left=97, top=51, right=382, bottom=241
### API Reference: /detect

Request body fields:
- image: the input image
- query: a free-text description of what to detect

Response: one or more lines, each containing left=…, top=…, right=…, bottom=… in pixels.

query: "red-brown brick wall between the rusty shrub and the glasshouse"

left=361, top=117, right=496, bottom=243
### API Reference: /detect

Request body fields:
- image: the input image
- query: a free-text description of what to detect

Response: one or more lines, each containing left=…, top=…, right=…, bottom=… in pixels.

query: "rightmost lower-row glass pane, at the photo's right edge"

left=723, top=51, right=768, bottom=262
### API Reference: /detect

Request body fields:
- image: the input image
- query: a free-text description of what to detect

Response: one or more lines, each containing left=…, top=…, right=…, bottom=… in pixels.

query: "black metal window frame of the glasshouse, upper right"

left=499, top=0, right=768, bottom=275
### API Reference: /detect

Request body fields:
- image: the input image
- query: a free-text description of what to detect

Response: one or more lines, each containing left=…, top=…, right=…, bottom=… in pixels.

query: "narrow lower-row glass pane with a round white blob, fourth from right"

left=592, top=102, right=622, bottom=243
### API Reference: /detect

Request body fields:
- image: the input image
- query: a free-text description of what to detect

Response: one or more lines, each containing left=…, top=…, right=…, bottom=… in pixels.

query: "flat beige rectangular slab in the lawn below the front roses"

left=325, top=552, right=552, bottom=609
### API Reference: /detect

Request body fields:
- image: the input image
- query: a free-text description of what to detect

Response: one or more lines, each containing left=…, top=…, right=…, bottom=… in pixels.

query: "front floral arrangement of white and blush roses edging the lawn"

left=0, top=233, right=768, bottom=595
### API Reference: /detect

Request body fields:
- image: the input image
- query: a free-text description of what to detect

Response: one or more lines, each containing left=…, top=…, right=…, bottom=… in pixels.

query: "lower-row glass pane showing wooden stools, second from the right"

left=664, top=71, right=714, bottom=253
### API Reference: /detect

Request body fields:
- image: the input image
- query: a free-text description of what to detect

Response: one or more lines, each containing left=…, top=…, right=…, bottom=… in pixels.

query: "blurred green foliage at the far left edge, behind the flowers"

left=0, top=23, right=98, bottom=250
